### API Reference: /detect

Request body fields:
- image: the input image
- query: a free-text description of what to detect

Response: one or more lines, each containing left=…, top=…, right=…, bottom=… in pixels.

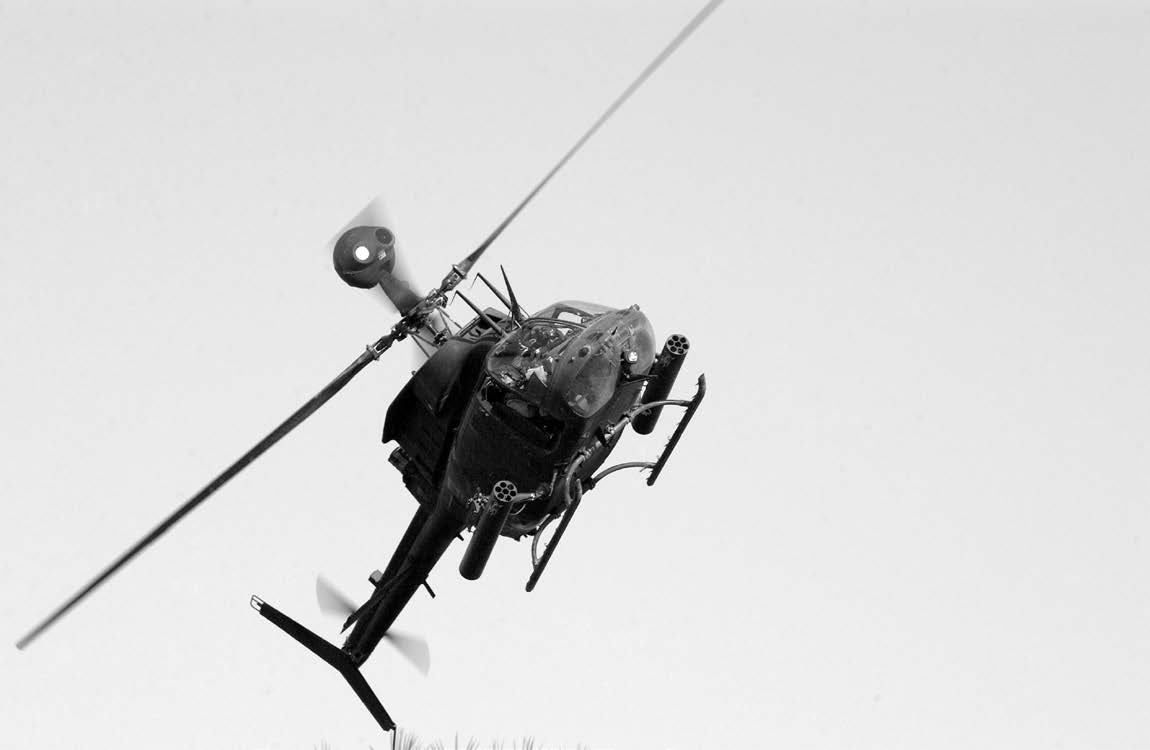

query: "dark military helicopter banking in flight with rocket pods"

left=16, top=0, right=720, bottom=730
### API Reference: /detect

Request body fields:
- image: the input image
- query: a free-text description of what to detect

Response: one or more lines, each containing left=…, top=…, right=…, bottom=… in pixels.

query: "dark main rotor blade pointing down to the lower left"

left=16, top=334, right=394, bottom=649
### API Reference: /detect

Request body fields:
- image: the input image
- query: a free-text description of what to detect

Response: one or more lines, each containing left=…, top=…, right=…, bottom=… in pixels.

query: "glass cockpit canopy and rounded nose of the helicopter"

left=486, top=301, right=656, bottom=419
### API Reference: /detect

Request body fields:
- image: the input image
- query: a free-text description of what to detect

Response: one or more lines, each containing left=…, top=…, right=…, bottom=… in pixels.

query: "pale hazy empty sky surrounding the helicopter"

left=0, top=0, right=1150, bottom=750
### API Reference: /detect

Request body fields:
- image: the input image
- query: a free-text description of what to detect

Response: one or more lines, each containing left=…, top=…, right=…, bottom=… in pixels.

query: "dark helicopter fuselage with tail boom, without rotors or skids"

left=344, top=301, right=656, bottom=661
